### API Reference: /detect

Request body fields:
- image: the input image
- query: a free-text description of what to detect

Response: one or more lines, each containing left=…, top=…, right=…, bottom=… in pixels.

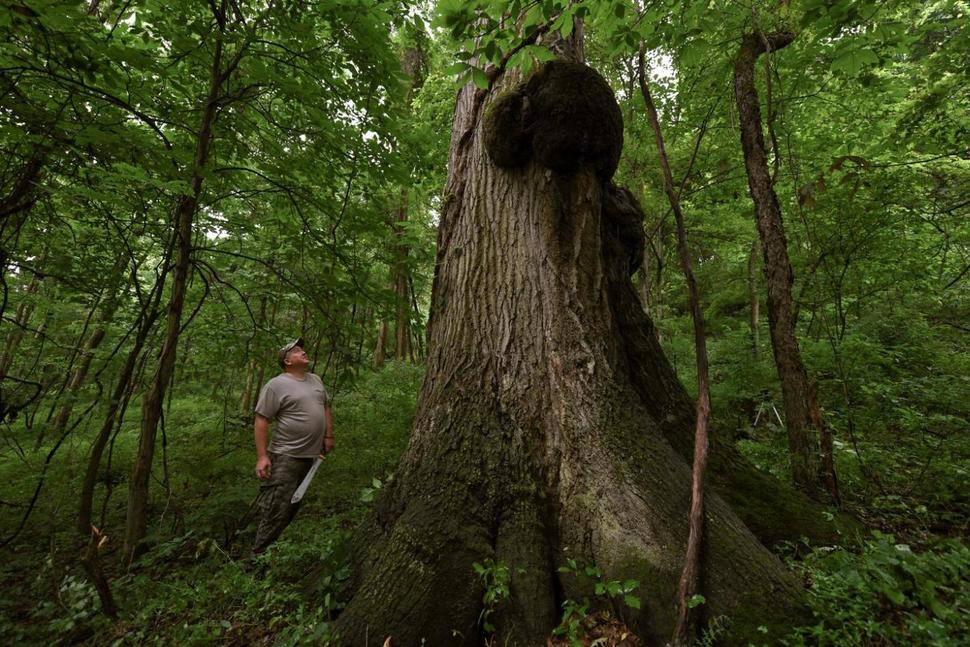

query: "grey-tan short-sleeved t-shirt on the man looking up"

left=256, top=373, right=329, bottom=457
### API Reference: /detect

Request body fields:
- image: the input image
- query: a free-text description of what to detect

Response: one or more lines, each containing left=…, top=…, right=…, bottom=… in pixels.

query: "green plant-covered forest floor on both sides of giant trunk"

left=0, top=365, right=970, bottom=645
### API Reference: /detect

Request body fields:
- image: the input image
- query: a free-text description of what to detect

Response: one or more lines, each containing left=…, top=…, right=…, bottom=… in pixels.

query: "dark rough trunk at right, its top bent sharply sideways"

left=734, top=32, right=821, bottom=498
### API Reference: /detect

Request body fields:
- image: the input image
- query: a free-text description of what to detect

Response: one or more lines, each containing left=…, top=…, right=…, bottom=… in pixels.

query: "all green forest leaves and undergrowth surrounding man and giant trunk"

left=0, top=0, right=970, bottom=645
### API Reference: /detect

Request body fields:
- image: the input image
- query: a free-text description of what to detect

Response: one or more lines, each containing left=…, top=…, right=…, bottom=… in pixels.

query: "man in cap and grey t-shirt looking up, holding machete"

left=253, top=339, right=333, bottom=554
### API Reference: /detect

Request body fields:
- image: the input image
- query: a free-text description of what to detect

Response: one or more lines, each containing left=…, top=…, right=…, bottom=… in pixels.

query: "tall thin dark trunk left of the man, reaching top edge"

left=125, top=16, right=233, bottom=559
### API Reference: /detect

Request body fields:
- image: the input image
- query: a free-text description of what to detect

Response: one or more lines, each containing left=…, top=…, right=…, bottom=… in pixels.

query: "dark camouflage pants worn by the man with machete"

left=253, top=453, right=313, bottom=554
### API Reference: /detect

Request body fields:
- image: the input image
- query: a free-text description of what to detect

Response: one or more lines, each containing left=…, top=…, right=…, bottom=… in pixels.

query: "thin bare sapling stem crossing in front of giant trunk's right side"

left=637, top=50, right=711, bottom=645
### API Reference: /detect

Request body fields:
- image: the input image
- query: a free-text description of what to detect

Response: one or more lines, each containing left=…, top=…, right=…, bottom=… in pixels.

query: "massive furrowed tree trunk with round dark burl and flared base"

left=336, top=61, right=804, bottom=646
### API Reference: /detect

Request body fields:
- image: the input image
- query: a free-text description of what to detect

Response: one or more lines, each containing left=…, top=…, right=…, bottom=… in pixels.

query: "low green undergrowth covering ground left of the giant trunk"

left=0, top=363, right=423, bottom=645
